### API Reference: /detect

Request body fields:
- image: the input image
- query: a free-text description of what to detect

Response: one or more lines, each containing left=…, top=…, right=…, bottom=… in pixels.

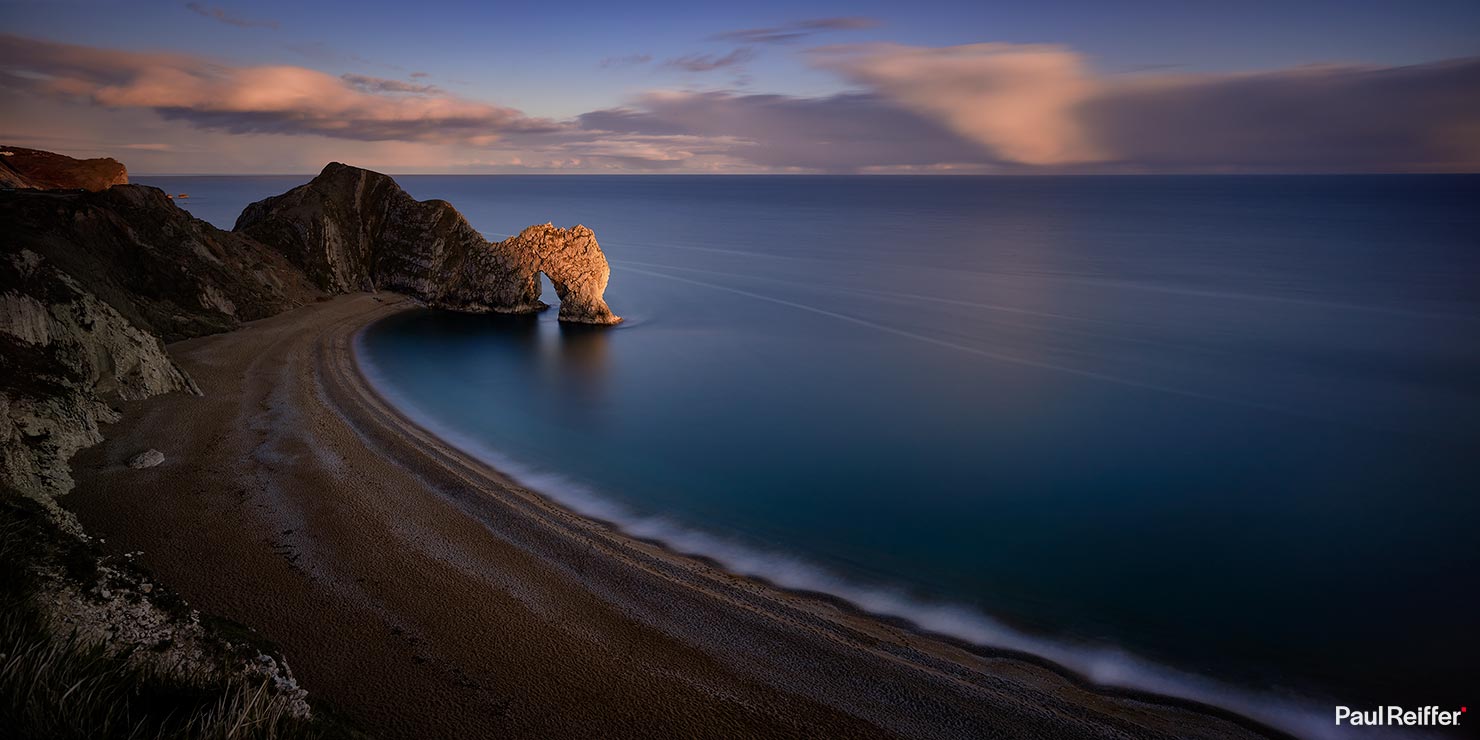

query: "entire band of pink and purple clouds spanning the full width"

left=0, top=34, right=1480, bottom=173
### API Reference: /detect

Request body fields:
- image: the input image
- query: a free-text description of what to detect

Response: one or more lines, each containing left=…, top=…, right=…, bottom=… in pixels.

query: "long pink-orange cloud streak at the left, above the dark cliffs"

left=0, top=34, right=561, bottom=145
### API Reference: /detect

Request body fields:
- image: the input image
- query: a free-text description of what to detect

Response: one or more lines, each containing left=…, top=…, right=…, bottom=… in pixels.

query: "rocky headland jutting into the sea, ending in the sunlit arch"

left=235, top=163, right=620, bottom=324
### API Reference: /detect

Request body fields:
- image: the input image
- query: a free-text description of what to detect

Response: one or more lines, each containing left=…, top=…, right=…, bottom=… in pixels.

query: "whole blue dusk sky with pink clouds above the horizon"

left=0, top=0, right=1480, bottom=175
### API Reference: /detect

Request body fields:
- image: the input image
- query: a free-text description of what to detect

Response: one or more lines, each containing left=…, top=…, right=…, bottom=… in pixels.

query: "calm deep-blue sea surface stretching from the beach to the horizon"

left=136, top=176, right=1480, bottom=734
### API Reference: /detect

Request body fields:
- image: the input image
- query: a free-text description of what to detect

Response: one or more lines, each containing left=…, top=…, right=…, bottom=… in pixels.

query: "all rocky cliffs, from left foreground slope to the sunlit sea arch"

left=0, top=147, right=619, bottom=734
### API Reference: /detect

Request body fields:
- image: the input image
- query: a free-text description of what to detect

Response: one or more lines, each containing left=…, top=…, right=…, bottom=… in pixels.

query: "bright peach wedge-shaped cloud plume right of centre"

left=813, top=43, right=1106, bottom=164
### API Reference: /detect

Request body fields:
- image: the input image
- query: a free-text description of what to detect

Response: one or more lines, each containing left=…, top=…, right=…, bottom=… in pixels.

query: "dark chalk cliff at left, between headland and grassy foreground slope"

left=0, top=185, right=321, bottom=502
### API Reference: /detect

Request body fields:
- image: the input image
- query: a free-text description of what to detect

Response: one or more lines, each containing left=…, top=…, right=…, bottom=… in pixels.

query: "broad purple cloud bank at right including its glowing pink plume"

left=577, top=44, right=1480, bottom=173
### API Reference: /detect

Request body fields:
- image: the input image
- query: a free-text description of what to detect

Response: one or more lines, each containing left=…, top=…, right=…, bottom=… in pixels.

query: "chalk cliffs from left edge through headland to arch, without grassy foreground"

left=0, top=149, right=620, bottom=500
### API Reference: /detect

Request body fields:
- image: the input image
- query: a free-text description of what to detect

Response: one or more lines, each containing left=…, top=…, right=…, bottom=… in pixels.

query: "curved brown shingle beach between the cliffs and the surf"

left=62, top=293, right=1274, bottom=739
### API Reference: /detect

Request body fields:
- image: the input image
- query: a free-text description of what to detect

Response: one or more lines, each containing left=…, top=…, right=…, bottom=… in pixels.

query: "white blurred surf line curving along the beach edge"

left=354, top=330, right=1425, bottom=739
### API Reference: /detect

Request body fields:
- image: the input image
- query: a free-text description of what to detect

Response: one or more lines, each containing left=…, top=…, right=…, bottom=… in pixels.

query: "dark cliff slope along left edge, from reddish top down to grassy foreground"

left=0, top=152, right=337, bottom=737
